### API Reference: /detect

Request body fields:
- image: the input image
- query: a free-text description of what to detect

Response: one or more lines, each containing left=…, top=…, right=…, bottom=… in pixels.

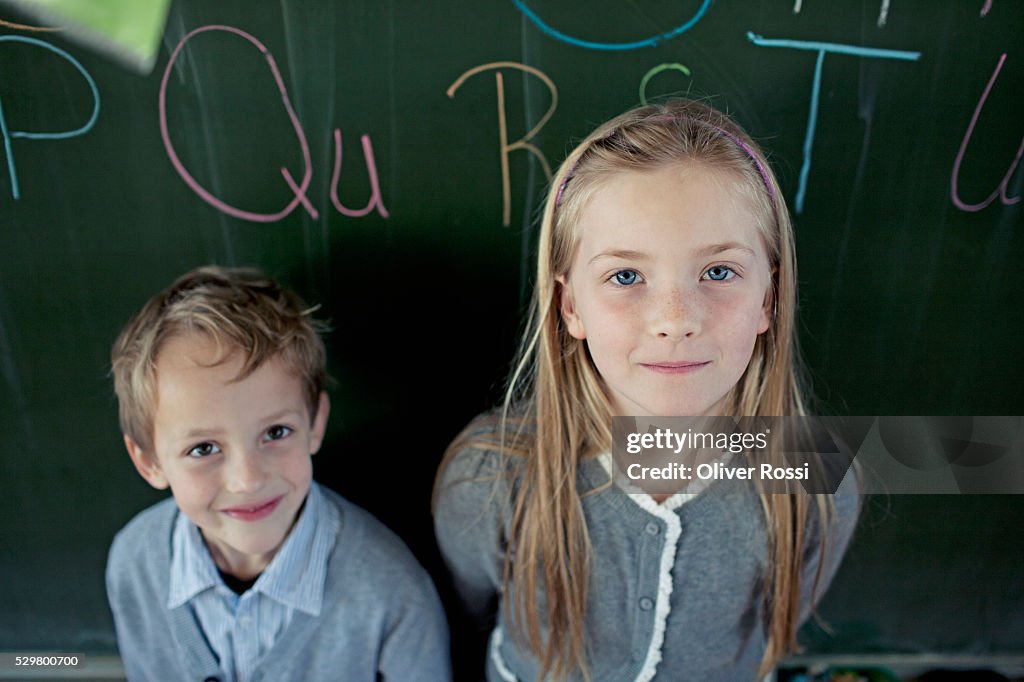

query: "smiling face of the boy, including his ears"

left=125, top=334, right=330, bottom=580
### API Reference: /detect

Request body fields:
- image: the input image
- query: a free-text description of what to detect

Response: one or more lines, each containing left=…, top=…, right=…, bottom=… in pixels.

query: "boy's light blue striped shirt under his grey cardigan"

left=167, top=482, right=341, bottom=682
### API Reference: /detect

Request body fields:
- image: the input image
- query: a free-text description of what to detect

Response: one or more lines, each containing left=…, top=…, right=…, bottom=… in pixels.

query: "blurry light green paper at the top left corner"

left=0, top=0, right=171, bottom=74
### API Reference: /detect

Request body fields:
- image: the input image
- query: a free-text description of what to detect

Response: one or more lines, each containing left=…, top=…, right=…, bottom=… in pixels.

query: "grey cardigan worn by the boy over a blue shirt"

left=106, top=483, right=452, bottom=682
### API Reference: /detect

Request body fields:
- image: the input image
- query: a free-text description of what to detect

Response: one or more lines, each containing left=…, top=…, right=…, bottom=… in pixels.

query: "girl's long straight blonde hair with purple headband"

left=442, top=99, right=828, bottom=679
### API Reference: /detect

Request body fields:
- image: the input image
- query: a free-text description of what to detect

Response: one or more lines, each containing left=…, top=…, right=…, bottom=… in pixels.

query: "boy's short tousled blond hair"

left=111, top=265, right=328, bottom=452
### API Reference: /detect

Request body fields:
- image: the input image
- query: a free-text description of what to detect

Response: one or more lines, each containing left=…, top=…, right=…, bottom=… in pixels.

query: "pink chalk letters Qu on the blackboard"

left=159, top=25, right=389, bottom=222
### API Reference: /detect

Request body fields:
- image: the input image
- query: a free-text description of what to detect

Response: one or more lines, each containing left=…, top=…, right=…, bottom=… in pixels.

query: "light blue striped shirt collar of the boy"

left=167, top=482, right=341, bottom=616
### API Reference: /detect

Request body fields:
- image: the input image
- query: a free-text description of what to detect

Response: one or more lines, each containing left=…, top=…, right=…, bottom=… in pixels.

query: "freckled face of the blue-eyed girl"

left=559, top=163, right=771, bottom=417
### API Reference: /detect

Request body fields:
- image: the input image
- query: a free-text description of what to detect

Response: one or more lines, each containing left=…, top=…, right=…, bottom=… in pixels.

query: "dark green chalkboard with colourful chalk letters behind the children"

left=0, top=0, right=1024, bottom=667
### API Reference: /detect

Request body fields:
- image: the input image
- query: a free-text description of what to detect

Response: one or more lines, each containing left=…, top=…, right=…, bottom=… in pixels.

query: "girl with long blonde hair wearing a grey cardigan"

left=434, top=100, right=857, bottom=682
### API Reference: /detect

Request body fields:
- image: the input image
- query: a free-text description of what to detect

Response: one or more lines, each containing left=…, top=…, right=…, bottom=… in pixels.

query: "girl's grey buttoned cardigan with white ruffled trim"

left=434, top=417, right=859, bottom=682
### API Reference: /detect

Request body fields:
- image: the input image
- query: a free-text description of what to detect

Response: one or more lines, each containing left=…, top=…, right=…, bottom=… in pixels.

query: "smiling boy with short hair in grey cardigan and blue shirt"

left=106, top=267, right=451, bottom=682
